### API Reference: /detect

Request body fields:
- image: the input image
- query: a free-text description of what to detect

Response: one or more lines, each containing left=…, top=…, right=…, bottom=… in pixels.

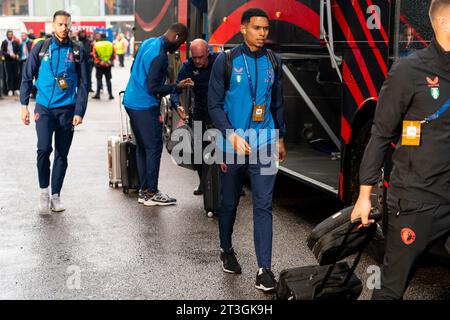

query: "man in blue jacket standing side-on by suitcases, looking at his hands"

left=123, top=23, right=192, bottom=206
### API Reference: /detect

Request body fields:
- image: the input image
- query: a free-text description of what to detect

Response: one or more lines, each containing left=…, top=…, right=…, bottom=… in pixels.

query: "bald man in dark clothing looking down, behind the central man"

left=170, top=39, right=218, bottom=195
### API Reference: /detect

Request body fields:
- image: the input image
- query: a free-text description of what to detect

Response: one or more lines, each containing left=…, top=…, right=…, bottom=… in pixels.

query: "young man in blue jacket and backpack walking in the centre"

left=208, top=8, right=286, bottom=292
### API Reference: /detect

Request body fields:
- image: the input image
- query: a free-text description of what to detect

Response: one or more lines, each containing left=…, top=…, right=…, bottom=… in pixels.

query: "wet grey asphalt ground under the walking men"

left=0, top=61, right=450, bottom=300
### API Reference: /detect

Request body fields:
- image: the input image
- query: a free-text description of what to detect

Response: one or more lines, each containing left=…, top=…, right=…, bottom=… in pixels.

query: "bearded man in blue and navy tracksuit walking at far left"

left=20, top=11, right=87, bottom=214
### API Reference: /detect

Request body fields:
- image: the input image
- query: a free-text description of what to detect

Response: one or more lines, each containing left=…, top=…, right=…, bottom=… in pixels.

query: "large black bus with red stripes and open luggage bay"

left=136, top=0, right=450, bottom=260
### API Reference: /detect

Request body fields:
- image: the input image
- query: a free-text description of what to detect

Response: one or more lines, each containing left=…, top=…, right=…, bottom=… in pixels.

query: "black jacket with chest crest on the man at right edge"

left=360, top=40, right=450, bottom=203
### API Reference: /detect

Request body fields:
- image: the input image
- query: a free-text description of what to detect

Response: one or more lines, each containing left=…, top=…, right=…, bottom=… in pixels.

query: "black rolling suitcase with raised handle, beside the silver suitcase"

left=119, top=91, right=140, bottom=193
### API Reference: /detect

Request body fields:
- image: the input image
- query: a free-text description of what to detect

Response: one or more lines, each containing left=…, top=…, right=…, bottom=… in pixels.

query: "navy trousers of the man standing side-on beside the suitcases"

left=126, top=107, right=163, bottom=193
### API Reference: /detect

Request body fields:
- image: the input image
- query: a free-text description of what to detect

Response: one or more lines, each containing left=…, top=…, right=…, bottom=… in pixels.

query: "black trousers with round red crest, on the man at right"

left=372, top=195, right=450, bottom=300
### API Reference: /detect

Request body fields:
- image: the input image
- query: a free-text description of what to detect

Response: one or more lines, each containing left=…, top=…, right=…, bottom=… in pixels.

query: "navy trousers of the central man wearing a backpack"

left=218, top=149, right=276, bottom=268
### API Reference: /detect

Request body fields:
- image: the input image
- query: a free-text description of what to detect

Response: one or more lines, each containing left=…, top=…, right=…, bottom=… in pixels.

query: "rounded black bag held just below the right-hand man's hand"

left=307, top=206, right=381, bottom=265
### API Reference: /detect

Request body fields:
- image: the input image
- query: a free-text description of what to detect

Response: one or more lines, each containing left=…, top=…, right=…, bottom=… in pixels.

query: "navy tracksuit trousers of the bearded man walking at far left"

left=34, top=104, right=75, bottom=194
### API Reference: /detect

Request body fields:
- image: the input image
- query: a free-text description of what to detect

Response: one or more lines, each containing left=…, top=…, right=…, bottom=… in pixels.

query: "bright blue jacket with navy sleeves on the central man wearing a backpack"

left=208, top=44, right=286, bottom=149
